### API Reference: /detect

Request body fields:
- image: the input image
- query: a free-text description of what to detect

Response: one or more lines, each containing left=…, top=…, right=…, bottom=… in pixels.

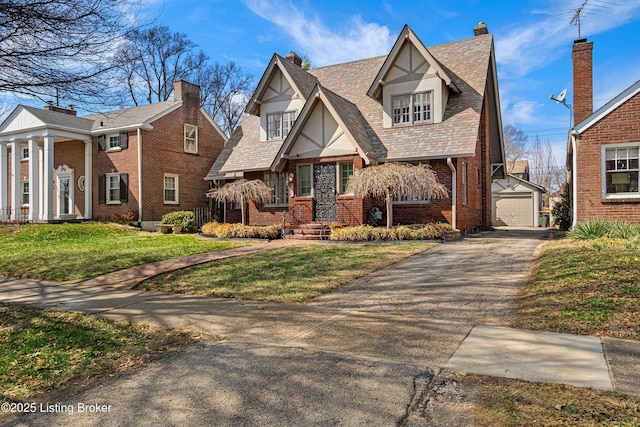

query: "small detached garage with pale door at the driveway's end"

left=491, top=175, right=546, bottom=227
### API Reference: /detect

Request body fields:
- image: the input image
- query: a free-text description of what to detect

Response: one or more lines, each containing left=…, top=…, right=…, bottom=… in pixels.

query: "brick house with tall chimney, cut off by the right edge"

left=567, top=39, right=640, bottom=226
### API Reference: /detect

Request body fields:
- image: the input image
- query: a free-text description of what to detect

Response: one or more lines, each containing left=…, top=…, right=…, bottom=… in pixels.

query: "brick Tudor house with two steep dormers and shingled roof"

left=207, top=23, right=505, bottom=232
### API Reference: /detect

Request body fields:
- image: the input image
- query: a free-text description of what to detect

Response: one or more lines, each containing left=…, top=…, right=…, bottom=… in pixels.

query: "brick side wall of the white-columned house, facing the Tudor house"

left=141, top=103, right=224, bottom=221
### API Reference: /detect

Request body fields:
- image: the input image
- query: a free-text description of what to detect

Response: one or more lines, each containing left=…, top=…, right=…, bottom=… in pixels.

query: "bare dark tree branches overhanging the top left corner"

left=0, top=0, right=134, bottom=100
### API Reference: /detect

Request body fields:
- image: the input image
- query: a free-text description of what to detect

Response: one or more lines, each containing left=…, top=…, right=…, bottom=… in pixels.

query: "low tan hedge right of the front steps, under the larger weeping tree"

left=329, top=223, right=451, bottom=242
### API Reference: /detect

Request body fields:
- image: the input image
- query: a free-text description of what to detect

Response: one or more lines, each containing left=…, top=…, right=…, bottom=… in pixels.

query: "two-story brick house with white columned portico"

left=0, top=81, right=227, bottom=230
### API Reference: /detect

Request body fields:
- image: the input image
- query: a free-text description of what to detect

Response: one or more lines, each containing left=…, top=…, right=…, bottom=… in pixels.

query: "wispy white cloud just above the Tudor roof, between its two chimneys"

left=245, top=0, right=395, bottom=67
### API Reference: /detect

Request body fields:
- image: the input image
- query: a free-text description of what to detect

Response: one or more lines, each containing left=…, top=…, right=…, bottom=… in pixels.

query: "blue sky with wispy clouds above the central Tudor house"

left=145, top=0, right=640, bottom=163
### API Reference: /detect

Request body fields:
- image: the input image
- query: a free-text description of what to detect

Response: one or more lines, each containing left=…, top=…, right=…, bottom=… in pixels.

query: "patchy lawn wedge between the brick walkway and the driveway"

left=140, top=243, right=436, bottom=302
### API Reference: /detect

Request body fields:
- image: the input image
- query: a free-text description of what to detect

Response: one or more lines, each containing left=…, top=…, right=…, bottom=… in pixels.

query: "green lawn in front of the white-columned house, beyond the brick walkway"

left=0, top=222, right=254, bottom=281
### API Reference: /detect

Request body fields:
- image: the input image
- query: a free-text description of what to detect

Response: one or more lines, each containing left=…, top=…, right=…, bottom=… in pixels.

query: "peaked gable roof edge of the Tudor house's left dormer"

left=245, top=54, right=318, bottom=116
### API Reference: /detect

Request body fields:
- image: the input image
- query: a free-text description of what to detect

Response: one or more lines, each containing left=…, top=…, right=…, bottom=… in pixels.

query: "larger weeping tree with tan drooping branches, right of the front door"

left=353, top=163, right=449, bottom=228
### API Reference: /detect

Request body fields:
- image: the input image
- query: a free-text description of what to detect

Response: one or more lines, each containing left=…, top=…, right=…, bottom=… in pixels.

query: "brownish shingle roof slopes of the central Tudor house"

left=209, top=34, right=493, bottom=177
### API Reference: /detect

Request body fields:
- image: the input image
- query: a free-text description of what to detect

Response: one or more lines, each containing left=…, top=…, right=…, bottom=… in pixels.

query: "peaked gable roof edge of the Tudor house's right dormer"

left=367, top=25, right=461, bottom=102
